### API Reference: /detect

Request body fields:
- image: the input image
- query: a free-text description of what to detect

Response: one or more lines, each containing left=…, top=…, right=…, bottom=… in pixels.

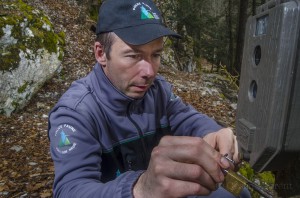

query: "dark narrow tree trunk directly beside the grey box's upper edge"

left=235, top=0, right=248, bottom=74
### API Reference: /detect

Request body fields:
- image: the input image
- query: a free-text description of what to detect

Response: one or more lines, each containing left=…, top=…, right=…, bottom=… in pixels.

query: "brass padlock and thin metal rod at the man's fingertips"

left=222, top=154, right=273, bottom=198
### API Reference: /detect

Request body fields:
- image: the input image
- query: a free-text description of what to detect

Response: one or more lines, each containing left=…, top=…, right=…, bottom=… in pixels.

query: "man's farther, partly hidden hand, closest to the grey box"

left=203, top=128, right=240, bottom=163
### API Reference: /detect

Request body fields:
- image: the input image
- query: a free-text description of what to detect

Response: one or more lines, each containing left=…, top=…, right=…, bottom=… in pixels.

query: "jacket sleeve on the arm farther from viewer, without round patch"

left=164, top=81, right=222, bottom=137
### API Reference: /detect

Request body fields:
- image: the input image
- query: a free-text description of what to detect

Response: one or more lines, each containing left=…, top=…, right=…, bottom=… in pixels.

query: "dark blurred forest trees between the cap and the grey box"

left=171, top=0, right=264, bottom=74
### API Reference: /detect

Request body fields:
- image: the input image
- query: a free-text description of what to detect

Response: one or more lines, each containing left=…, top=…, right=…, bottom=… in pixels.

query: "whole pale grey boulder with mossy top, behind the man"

left=0, top=1, right=64, bottom=116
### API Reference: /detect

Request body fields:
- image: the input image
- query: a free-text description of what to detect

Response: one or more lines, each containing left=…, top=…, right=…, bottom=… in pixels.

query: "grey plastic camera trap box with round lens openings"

left=236, top=0, right=300, bottom=171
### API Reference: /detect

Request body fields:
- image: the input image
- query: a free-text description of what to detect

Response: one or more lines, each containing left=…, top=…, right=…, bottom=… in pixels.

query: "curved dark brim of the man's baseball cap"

left=113, top=24, right=182, bottom=45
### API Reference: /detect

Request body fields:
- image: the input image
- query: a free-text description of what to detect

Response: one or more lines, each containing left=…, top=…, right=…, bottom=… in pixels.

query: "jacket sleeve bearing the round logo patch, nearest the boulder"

left=48, top=107, right=142, bottom=198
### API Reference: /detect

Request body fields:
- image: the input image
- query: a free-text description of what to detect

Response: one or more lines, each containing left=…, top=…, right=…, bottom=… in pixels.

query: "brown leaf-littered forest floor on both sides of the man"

left=0, top=0, right=236, bottom=198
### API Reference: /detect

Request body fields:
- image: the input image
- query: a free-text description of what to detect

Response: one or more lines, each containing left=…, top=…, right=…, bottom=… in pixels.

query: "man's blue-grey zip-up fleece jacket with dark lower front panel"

left=49, top=64, right=221, bottom=198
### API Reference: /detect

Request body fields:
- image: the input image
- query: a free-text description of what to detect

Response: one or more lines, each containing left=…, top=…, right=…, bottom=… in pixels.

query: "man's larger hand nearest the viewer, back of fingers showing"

left=133, top=136, right=230, bottom=198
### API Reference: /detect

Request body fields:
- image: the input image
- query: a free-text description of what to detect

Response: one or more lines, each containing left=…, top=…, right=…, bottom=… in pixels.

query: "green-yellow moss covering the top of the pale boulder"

left=0, top=0, right=64, bottom=71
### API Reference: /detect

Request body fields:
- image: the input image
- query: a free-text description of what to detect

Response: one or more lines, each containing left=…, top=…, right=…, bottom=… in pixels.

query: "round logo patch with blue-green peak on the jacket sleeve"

left=55, top=124, right=77, bottom=154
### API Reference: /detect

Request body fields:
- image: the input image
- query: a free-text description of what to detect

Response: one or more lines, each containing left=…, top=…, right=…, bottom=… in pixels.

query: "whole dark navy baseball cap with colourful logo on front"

left=96, top=0, right=181, bottom=45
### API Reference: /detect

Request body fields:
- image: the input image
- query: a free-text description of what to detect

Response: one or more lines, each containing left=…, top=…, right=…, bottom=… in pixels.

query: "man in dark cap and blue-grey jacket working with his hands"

left=49, top=0, right=251, bottom=198
